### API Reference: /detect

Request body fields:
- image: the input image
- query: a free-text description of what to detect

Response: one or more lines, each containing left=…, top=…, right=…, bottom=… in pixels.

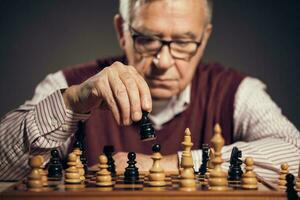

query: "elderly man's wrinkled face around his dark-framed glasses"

left=120, top=0, right=211, bottom=99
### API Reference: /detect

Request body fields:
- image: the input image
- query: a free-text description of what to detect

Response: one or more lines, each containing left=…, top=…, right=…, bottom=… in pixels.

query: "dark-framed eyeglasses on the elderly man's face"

left=129, top=26, right=202, bottom=60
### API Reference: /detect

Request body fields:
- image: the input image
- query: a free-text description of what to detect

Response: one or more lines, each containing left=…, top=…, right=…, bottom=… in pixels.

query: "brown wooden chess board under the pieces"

left=0, top=172, right=286, bottom=200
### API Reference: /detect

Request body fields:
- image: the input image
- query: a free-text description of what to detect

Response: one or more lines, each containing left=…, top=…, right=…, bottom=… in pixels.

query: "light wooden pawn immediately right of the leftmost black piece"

left=65, top=153, right=81, bottom=184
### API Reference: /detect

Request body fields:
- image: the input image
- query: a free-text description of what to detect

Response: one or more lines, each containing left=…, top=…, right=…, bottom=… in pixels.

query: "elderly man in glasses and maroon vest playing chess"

left=0, top=0, right=300, bottom=179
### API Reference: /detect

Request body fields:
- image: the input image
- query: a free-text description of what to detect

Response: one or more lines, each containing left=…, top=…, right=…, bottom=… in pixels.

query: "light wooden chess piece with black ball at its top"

left=149, top=144, right=166, bottom=187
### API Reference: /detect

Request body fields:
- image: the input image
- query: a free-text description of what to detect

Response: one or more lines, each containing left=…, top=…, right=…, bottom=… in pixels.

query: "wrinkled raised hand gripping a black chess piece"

left=63, top=62, right=152, bottom=125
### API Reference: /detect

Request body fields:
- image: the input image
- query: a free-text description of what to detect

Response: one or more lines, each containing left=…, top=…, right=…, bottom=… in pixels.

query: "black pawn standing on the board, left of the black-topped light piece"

left=124, top=152, right=139, bottom=183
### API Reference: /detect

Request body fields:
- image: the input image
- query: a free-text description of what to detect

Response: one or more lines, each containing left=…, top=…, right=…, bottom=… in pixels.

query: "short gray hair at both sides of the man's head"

left=119, top=0, right=213, bottom=26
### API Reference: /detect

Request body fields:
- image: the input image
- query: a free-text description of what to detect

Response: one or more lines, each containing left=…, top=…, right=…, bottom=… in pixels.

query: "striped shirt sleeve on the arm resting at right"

left=179, top=77, right=300, bottom=181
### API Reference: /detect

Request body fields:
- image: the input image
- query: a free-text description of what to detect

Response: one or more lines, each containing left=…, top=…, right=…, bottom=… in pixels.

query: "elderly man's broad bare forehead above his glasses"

left=132, top=0, right=206, bottom=38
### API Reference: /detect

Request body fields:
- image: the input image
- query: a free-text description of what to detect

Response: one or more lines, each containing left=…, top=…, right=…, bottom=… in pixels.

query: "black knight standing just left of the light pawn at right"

left=228, top=147, right=243, bottom=181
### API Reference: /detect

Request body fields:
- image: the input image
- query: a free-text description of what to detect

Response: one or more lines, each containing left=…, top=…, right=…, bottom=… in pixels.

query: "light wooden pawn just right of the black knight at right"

left=242, top=157, right=257, bottom=190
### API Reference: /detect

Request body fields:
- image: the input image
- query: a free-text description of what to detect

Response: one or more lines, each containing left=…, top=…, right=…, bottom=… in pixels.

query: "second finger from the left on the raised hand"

left=108, top=70, right=131, bottom=125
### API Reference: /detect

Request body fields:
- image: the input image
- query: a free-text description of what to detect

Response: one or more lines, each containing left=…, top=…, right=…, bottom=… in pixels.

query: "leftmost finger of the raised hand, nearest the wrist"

left=95, top=76, right=121, bottom=124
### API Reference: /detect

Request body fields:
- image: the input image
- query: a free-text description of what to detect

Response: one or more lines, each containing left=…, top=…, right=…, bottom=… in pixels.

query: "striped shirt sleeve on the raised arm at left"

left=0, top=71, right=89, bottom=180
